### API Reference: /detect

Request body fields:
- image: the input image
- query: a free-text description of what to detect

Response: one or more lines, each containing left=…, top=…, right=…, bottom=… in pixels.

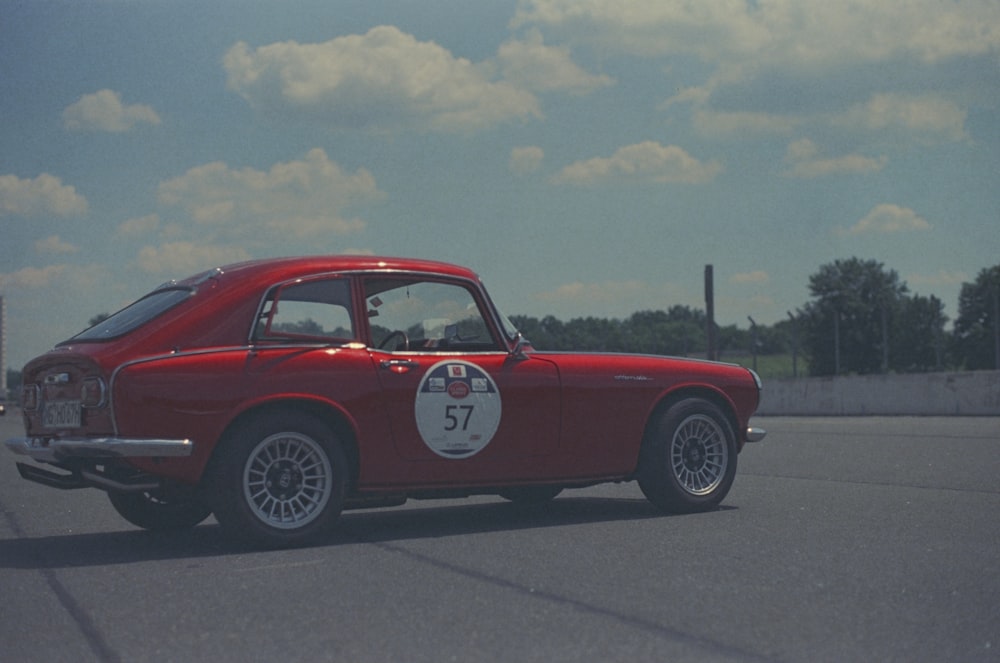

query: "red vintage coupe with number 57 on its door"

left=6, top=256, right=764, bottom=546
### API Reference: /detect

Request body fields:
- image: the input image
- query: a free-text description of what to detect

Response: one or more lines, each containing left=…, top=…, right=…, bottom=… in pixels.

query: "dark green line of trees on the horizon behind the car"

left=511, top=258, right=1000, bottom=376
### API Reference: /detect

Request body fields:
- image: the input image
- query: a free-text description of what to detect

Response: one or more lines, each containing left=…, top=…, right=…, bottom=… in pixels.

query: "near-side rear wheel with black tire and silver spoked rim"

left=207, top=412, right=349, bottom=548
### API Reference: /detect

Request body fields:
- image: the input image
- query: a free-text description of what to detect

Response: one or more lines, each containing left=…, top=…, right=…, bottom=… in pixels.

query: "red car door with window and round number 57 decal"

left=364, top=276, right=562, bottom=483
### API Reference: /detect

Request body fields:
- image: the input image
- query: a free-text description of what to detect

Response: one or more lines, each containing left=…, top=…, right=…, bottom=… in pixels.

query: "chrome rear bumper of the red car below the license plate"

left=4, top=437, right=194, bottom=463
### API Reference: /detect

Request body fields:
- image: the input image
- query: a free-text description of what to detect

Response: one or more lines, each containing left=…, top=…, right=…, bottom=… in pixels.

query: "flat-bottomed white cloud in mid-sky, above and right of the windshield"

left=554, top=141, right=722, bottom=184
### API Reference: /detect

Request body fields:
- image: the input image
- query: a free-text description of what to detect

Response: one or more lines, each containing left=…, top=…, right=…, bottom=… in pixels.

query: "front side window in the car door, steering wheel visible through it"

left=365, top=278, right=498, bottom=352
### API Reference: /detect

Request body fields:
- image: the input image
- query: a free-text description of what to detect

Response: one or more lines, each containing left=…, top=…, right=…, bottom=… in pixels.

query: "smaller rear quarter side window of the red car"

left=254, top=279, right=357, bottom=341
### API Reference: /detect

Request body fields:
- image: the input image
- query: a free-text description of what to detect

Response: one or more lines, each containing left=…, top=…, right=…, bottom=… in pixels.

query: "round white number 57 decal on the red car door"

left=416, top=359, right=502, bottom=458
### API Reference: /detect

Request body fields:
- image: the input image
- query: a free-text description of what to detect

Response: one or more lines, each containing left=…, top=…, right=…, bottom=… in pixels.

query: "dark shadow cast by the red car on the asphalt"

left=0, top=497, right=736, bottom=570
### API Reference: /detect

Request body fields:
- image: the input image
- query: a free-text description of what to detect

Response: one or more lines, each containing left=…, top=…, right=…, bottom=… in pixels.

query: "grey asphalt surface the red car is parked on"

left=0, top=413, right=1000, bottom=663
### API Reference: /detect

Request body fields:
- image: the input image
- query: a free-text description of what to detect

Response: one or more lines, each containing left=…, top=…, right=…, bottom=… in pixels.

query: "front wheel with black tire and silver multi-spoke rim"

left=638, top=398, right=737, bottom=513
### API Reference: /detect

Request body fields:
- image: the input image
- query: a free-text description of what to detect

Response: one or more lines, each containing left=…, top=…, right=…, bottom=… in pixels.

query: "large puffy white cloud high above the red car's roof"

left=224, top=26, right=541, bottom=131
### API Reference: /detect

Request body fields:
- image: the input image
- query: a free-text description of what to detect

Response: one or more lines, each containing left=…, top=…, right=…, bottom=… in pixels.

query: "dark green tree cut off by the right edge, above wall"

left=951, top=264, right=1000, bottom=370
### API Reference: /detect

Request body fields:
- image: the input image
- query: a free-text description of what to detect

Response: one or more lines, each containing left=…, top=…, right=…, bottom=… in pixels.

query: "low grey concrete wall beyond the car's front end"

left=757, top=371, right=1000, bottom=416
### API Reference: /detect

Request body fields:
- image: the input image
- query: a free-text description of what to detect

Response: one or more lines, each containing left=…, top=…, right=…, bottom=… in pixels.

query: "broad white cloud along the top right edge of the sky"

left=512, top=0, right=1000, bottom=68
